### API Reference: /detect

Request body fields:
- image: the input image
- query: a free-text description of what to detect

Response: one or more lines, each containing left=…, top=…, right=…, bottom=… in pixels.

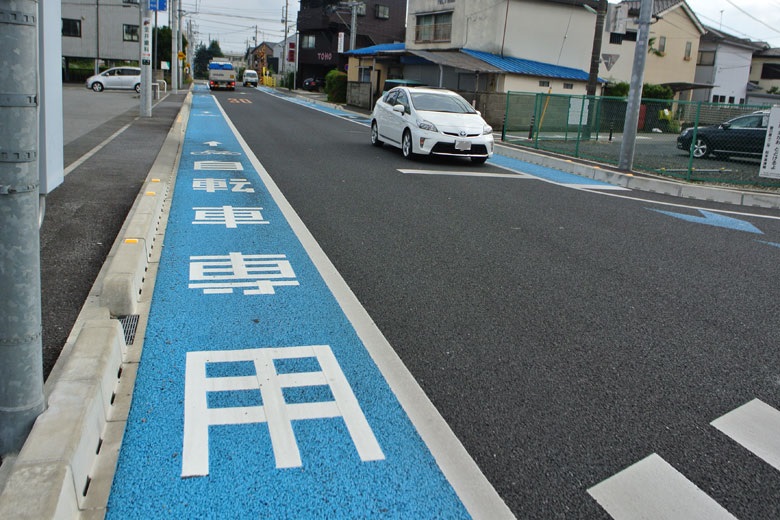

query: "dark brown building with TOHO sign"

left=298, top=0, right=406, bottom=86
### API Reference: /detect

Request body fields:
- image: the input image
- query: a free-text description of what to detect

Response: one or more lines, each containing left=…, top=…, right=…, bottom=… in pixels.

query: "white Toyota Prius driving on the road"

left=371, top=87, right=493, bottom=164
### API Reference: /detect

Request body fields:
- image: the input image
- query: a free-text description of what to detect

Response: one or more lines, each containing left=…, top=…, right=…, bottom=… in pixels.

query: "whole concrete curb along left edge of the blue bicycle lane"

left=0, top=96, right=191, bottom=520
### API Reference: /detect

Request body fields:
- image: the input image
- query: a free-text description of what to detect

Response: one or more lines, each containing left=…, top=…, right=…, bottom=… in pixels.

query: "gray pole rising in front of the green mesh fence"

left=618, top=0, right=653, bottom=171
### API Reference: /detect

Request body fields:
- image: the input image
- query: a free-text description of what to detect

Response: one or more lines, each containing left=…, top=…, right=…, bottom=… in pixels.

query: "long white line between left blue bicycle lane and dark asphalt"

left=217, top=100, right=515, bottom=520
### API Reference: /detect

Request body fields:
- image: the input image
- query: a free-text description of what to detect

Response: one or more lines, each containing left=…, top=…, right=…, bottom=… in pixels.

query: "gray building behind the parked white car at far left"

left=62, top=0, right=141, bottom=78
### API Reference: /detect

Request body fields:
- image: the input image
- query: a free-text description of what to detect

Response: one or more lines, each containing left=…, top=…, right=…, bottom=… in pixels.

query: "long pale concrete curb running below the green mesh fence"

left=496, top=144, right=780, bottom=208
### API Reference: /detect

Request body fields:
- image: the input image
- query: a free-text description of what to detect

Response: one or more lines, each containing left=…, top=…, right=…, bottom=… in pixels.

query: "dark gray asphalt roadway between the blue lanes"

left=216, top=89, right=780, bottom=518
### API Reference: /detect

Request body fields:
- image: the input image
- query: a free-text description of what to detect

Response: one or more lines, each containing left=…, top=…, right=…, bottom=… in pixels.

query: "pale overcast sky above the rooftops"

left=158, top=0, right=780, bottom=53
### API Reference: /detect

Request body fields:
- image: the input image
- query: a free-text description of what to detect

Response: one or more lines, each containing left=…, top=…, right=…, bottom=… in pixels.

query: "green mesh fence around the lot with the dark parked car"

left=502, top=92, right=780, bottom=187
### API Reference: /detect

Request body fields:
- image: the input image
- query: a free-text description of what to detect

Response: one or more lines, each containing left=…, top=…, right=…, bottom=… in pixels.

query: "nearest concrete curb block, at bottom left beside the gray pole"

left=0, top=320, right=125, bottom=518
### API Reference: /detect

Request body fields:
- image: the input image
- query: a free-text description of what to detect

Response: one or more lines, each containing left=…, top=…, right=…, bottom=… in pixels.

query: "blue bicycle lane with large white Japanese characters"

left=106, top=89, right=510, bottom=519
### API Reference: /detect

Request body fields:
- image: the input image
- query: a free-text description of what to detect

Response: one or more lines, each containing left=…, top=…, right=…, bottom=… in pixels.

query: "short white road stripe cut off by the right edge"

left=710, top=399, right=780, bottom=470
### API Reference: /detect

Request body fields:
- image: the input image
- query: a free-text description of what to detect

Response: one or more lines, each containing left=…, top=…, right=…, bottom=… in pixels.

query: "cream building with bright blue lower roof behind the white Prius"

left=404, top=0, right=598, bottom=94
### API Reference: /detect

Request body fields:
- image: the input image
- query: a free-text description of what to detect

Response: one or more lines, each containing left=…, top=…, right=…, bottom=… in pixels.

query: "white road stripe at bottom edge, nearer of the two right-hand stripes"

left=588, top=453, right=736, bottom=520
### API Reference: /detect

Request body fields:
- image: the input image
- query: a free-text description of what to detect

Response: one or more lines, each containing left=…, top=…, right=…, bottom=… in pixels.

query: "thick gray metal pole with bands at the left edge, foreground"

left=0, top=0, right=46, bottom=455
